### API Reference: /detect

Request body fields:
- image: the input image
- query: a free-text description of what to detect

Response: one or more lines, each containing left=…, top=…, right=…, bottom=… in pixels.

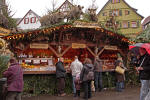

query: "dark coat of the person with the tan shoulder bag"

left=115, top=60, right=125, bottom=82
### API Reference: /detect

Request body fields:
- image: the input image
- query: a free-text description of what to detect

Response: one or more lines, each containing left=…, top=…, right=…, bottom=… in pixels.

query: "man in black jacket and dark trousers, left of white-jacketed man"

left=56, top=57, right=66, bottom=96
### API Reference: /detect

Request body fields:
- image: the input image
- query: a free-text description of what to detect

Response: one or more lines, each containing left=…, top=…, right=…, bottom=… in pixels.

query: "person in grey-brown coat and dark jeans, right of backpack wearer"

left=94, top=56, right=103, bottom=91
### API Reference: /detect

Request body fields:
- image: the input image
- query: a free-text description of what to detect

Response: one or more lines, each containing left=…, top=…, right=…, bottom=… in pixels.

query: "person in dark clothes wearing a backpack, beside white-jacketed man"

left=80, top=58, right=94, bottom=100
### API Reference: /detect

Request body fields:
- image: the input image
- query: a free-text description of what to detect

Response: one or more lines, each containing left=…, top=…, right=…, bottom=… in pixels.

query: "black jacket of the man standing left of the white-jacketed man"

left=56, top=61, right=66, bottom=78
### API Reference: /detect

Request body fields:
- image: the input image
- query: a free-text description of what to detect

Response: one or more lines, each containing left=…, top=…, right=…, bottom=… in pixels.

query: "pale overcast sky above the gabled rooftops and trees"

left=6, top=0, right=150, bottom=18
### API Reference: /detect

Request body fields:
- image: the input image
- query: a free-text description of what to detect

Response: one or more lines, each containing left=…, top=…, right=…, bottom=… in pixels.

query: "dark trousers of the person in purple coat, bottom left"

left=6, top=91, right=21, bottom=100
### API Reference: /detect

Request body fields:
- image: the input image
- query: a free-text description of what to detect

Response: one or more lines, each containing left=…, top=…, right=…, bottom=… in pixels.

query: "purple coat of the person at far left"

left=3, top=63, right=23, bottom=92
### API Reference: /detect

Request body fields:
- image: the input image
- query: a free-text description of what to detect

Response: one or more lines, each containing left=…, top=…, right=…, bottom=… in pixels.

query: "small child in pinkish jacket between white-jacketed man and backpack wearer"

left=75, top=73, right=81, bottom=97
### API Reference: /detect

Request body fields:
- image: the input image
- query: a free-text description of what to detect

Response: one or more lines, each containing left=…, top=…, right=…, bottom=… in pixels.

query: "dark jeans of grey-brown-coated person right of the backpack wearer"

left=94, top=72, right=103, bottom=91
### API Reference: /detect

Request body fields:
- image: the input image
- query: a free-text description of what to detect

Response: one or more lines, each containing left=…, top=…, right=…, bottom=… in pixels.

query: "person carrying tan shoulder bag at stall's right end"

left=115, top=59, right=125, bottom=92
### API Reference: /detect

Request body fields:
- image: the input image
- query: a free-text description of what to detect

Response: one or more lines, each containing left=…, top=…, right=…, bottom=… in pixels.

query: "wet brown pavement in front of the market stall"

left=23, top=87, right=140, bottom=100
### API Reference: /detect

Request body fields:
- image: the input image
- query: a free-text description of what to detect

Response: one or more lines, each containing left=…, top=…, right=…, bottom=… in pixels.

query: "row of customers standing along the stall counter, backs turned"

left=56, top=56, right=125, bottom=100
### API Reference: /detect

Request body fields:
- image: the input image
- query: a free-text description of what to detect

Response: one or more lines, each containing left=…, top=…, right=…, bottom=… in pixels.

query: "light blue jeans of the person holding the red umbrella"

left=140, top=80, right=150, bottom=100
